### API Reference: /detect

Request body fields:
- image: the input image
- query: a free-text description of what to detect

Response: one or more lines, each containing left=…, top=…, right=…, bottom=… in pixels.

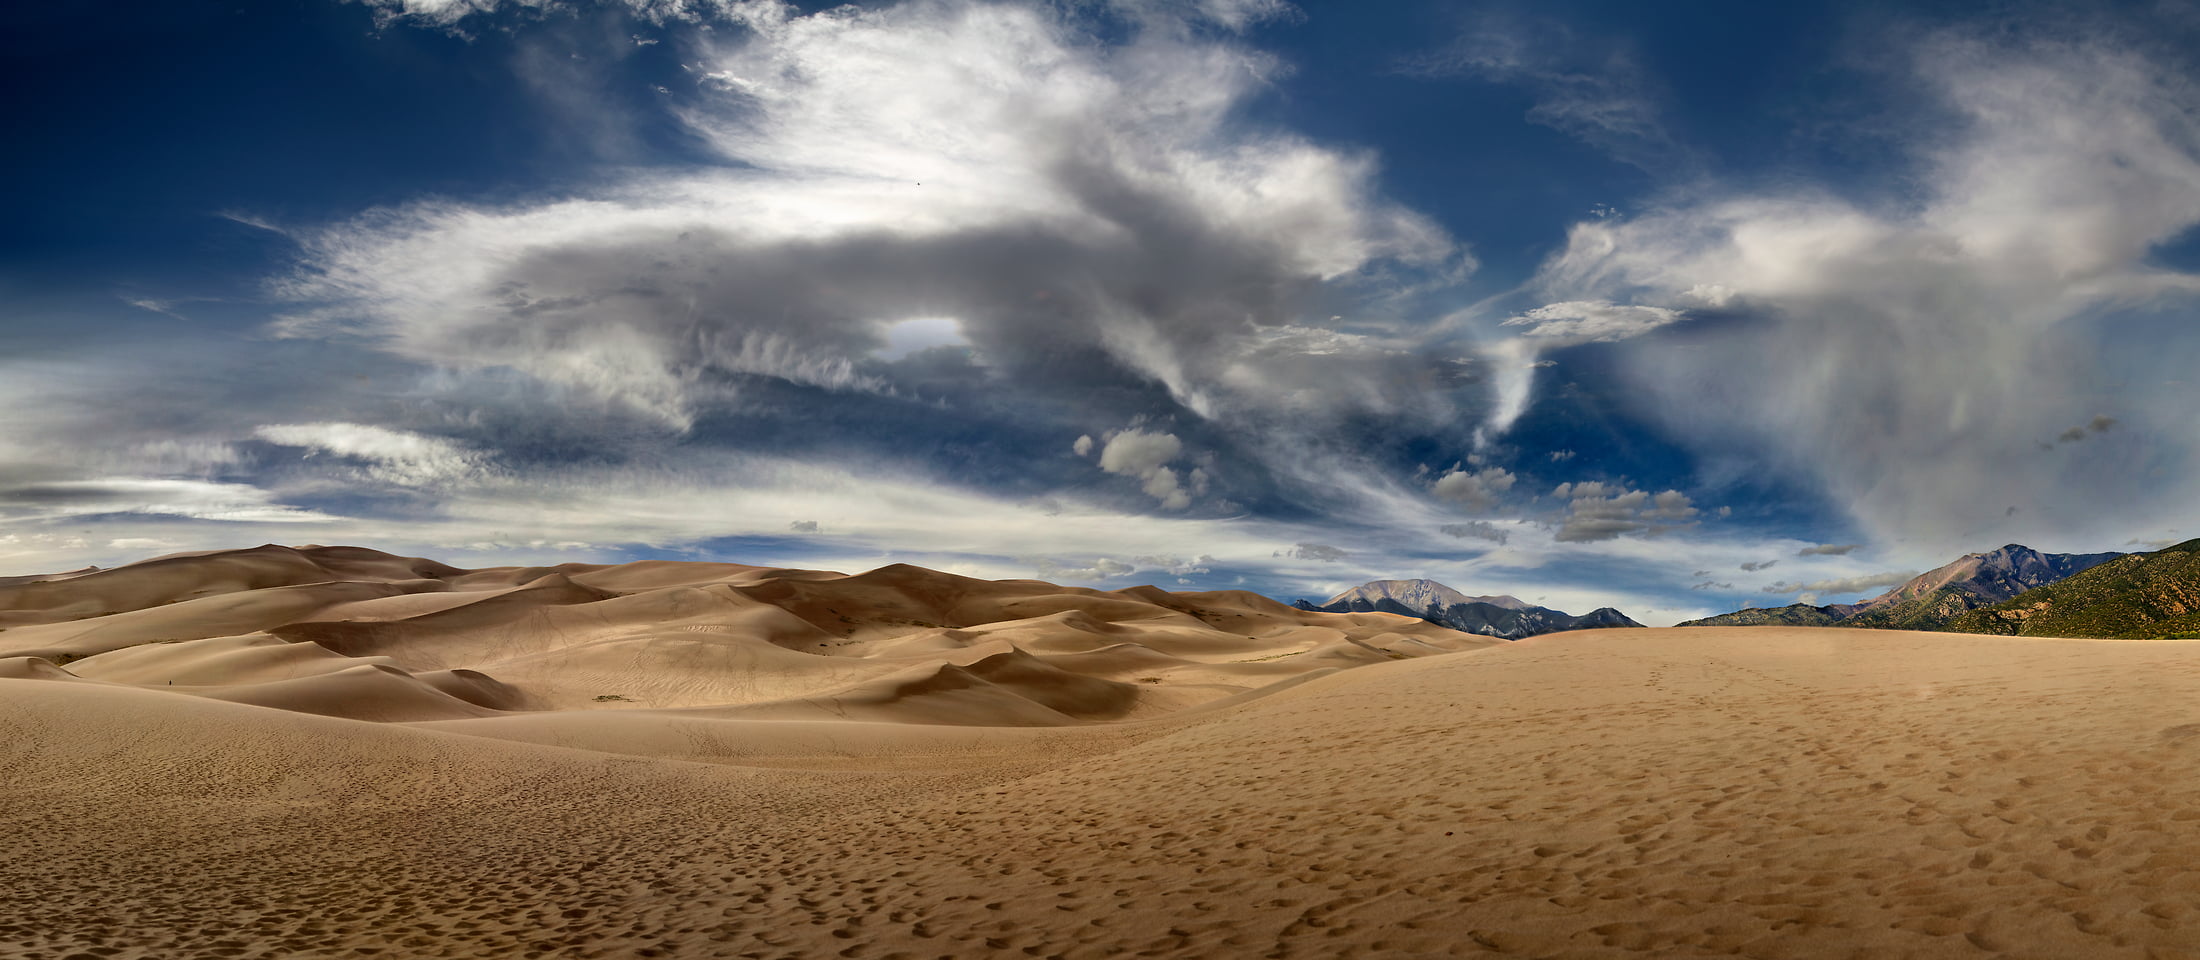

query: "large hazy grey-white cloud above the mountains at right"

left=1522, top=29, right=2200, bottom=553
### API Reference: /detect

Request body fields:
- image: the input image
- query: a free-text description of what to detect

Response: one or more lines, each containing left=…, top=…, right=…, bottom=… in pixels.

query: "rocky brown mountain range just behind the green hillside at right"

left=1679, top=544, right=2125, bottom=630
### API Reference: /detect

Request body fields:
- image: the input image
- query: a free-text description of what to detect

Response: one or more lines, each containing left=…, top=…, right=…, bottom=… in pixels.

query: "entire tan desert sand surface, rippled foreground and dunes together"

left=0, top=548, right=2200, bottom=960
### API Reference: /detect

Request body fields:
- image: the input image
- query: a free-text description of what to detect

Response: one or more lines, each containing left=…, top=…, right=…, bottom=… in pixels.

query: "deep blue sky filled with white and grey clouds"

left=0, top=0, right=2200, bottom=625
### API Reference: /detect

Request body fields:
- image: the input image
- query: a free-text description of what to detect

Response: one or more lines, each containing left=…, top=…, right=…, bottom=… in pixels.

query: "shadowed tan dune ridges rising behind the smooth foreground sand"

left=0, top=546, right=1489, bottom=724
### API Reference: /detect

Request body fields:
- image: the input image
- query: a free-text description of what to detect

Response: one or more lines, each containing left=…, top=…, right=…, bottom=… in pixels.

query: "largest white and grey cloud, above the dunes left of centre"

left=288, top=0, right=1465, bottom=440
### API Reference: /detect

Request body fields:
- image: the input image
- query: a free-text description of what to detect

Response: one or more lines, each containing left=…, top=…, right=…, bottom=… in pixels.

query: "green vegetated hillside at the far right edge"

left=1940, top=539, right=2200, bottom=641
